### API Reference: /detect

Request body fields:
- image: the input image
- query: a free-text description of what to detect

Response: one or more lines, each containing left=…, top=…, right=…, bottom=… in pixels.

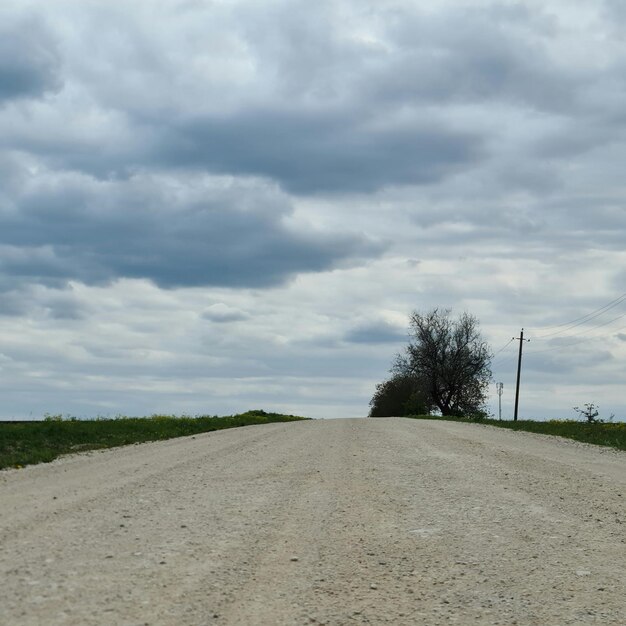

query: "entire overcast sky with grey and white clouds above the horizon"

left=0, top=0, right=626, bottom=418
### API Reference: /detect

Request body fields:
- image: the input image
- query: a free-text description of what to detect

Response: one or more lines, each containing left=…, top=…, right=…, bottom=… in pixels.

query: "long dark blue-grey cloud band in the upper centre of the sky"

left=154, top=109, right=481, bottom=194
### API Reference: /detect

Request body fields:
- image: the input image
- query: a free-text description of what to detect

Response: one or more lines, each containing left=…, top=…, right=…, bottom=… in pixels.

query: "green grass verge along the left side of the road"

left=0, top=410, right=307, bottom=469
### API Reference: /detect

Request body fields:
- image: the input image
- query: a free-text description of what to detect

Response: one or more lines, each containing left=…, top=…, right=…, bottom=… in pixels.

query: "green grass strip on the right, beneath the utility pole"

left=402, top=415, right=626, bottom=450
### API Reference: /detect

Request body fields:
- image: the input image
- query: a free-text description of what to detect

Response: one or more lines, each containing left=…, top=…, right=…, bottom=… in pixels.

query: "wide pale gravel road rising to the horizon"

left=0, top=419, right=626, bottom=626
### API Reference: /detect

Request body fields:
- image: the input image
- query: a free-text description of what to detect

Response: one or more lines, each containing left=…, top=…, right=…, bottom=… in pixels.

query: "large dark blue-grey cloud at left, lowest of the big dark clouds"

left=0, top=171, right=382, bottom=288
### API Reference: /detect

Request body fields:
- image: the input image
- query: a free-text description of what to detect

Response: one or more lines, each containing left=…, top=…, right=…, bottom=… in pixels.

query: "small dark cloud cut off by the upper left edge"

left=0, top=18, right=61, bottom=103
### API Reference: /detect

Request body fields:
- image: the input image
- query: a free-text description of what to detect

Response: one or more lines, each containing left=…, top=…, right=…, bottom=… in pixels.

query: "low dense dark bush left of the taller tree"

left=370, top=374, right=433, bottom=417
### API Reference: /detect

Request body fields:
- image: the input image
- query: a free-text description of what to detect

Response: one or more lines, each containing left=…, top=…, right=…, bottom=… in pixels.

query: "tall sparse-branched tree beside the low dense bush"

left=392, top=309, right=491, bottom=416
